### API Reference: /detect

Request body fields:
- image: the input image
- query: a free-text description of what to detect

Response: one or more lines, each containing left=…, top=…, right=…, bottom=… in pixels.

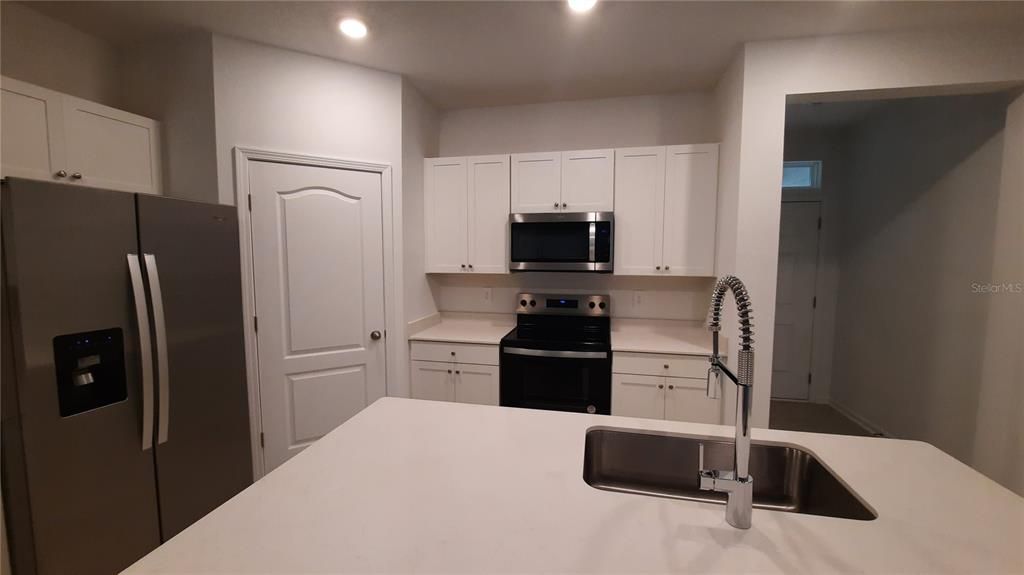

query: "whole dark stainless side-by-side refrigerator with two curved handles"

left=0, top=178, right=252, bottom=575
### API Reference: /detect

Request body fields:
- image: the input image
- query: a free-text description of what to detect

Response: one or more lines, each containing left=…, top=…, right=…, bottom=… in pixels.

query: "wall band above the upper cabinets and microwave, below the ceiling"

left=440, top=92, right=716, bottom=156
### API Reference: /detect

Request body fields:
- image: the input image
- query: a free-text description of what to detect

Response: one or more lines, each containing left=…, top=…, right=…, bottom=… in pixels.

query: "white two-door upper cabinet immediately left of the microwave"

left=423, top=156, right=510, bottom=273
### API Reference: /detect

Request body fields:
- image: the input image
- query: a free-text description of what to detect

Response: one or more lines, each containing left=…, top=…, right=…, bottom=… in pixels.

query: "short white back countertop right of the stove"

left=611, top=318, right=716, bottom=355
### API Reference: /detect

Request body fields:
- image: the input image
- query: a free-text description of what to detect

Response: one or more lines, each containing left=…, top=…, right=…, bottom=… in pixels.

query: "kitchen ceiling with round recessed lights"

left=24, top=1, right=1024, bottom=108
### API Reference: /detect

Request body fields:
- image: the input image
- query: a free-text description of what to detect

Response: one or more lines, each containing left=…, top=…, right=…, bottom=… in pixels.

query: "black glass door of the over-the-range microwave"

left=512, top=222, right=590, bottom=263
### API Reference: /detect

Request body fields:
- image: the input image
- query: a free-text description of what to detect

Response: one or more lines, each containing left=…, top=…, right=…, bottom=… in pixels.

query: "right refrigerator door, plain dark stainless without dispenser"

left=137, top=195, right=253, bottom=540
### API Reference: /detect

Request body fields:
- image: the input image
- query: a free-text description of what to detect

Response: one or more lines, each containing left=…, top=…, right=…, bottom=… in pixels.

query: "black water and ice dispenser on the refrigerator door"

left=53, top=327, right=128, bottom=417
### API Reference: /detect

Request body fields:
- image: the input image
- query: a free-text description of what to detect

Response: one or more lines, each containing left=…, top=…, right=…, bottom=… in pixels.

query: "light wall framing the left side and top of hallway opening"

left=720, top=30, right=1024, bottom=427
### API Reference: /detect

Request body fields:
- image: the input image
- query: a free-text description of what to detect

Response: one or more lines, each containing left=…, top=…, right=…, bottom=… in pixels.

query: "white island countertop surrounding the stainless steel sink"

left=126, top=398, right=1024, bottom=573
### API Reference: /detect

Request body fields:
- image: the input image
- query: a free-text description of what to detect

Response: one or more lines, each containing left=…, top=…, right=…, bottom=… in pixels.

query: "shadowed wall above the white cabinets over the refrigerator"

left=0, top=2, right=121, bottom=107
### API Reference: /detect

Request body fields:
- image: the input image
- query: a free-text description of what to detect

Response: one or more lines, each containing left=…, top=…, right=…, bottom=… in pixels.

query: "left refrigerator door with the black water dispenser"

left=0, top=179, right=160, bottom=574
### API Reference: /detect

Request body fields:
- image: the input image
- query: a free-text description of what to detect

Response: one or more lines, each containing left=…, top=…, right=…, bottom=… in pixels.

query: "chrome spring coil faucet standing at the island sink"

left=697, top=275, right=754, bottom=529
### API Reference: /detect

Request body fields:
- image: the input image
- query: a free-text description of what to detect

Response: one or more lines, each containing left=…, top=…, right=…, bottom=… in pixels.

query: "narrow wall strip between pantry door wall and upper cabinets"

left=401, top=80, right=440, bottom=341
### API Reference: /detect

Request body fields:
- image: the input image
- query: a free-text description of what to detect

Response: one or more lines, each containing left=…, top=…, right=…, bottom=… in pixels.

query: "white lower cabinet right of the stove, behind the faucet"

left=611, top=354, right=722, bottom=424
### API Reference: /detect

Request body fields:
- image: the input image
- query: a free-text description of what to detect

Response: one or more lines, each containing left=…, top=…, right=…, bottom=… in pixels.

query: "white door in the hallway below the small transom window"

left=771, top=202, right=820, bottom=399
